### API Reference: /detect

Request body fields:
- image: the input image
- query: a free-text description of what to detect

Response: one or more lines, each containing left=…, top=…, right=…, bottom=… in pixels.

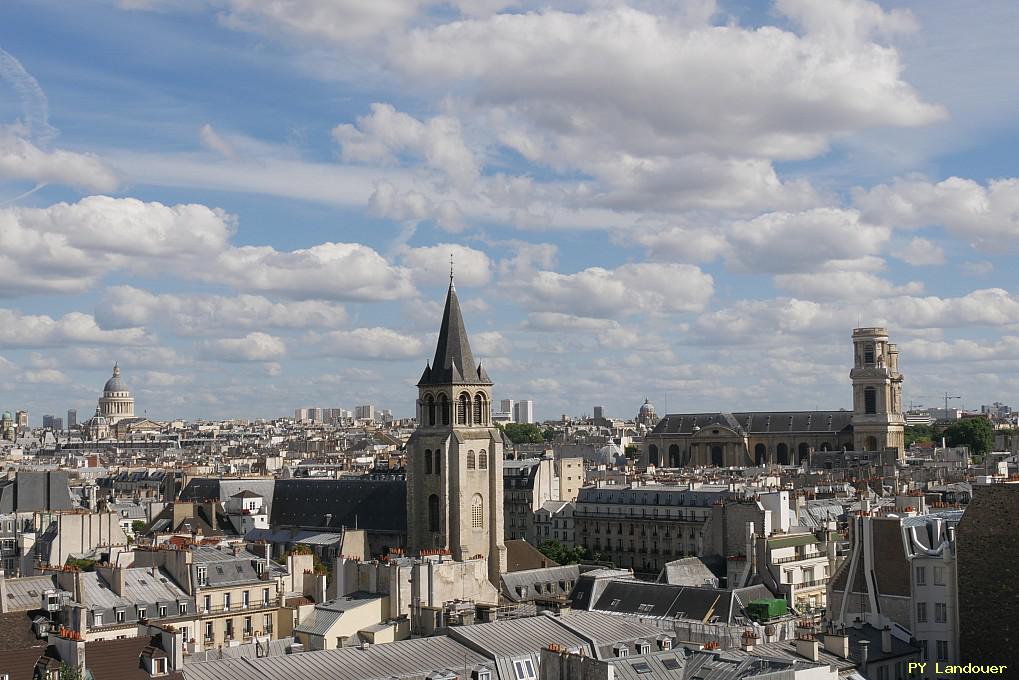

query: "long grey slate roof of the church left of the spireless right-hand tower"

left=650, top=411, right=853, bottom=434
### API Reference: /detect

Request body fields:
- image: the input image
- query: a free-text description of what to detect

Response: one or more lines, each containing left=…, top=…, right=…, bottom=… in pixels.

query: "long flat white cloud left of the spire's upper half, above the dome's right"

left=96, top=285, right=346, bottom=335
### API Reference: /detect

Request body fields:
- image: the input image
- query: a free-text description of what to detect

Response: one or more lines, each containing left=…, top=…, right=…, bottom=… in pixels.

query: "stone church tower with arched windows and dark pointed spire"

left=407, top=271, right=506, bottom=587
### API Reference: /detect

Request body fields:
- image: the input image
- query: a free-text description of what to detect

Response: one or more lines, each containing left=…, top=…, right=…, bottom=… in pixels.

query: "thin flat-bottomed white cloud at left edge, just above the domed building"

left=0, top=309, right=155, bottom=348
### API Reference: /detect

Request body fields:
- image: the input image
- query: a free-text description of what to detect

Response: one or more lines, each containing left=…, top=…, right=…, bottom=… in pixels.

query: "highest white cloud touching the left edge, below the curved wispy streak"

left=0, top=126, right=118, bottom=192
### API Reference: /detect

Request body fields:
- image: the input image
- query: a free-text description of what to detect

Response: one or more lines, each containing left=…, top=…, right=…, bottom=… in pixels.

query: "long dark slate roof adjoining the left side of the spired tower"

left=269, top=479, right=407, bottom=533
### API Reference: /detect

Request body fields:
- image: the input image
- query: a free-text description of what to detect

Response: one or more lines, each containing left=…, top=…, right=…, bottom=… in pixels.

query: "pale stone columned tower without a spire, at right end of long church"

left=849, top=328, right=906, bottom=460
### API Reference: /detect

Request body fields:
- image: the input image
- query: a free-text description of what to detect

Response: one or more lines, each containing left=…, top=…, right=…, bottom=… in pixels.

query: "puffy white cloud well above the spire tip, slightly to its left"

left=332, top=104, right=479, bottom=187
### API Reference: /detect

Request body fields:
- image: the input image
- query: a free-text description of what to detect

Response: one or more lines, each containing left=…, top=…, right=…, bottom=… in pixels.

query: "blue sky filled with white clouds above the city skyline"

left=0, top=0, right=1019, bottom=424
